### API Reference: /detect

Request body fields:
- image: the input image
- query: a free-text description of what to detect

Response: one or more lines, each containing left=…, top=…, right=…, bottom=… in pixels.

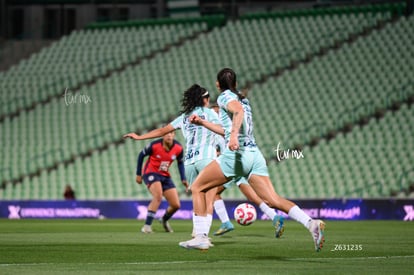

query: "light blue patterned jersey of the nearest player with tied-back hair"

left=217, top=90, right=256, bottom=150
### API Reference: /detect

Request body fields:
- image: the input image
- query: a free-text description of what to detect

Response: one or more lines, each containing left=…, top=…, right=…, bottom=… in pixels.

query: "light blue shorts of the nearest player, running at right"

left=217, top=147, right=269, bottom=182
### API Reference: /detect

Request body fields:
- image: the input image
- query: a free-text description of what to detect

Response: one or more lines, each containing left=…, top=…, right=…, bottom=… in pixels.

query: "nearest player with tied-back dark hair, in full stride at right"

left=179, top=68, right=325, bottom=251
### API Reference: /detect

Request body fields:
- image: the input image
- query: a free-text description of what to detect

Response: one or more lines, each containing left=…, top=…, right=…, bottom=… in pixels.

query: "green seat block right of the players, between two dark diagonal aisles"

left=251, top=14, right=414, bottom=157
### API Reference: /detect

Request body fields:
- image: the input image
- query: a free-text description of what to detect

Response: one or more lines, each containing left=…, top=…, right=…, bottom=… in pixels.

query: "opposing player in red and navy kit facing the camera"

left=136, top=132, right=188, bottom=233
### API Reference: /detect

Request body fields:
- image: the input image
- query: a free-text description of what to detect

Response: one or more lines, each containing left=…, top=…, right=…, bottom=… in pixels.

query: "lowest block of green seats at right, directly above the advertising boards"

left=269, top=105, right=414, bottom=201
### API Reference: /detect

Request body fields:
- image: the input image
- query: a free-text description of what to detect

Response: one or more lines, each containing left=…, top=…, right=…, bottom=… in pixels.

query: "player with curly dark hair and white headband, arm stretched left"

left=124, top=84, right=219, bottom=245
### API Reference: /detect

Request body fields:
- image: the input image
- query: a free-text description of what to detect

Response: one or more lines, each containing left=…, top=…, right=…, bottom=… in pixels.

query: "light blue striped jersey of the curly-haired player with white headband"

left=171, top=107, right=220, bottom=165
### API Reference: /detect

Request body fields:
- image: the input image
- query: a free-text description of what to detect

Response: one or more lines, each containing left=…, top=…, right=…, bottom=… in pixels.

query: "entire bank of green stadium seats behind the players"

left=0, top=2, right=414, bottom=199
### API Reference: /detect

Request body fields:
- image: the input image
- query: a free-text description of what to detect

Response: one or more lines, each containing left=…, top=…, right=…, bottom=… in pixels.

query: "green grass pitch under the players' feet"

left=0, top=219, right=414, bottom=275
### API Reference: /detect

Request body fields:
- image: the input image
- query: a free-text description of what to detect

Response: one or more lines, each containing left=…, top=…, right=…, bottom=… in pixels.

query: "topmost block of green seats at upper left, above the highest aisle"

left=0, top=22, right=207, bottom=118
